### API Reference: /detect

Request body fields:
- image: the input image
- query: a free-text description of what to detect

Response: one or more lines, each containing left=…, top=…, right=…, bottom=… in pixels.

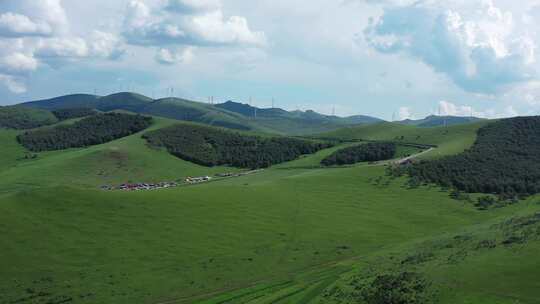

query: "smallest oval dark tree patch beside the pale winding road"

left=321, top=142, right=397, bottom=166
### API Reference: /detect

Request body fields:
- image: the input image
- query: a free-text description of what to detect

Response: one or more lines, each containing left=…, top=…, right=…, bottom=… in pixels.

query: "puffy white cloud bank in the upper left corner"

left=0, top=0, right=125, bottom=93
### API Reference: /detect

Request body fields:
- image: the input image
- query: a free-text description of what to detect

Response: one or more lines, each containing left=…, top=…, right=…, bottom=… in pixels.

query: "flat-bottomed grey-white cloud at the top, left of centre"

left=124, top=0, right=266, bottom=47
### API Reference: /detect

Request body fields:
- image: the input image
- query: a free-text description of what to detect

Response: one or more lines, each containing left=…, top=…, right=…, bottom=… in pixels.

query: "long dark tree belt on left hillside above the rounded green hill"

left=17, top=113, right=152, bottom=152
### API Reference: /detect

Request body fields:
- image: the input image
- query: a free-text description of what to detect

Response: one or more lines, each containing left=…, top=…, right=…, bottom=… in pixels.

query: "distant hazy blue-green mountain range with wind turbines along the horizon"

left=15, top=92, right=479, bottom=135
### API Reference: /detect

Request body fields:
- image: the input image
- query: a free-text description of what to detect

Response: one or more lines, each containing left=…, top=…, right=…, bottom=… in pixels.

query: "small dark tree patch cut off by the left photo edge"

left=0, top=106, right=58, bottom=130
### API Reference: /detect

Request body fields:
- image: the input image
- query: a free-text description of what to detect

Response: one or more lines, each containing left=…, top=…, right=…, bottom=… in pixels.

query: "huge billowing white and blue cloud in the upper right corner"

left=364, top=0, right=537, bottom=94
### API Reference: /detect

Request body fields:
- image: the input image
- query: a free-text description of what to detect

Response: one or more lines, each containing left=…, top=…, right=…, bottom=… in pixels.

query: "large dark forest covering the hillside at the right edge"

left=404, top=117, right=540, bottom=197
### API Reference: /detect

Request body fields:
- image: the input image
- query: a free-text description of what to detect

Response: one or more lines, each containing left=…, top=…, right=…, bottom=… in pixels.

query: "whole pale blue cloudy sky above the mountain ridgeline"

left=0, top=0, right=540, bottom=120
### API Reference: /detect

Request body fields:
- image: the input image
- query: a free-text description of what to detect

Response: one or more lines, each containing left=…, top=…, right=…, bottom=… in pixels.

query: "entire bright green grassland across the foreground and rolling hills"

left=0, top=119, right=540, bottom=304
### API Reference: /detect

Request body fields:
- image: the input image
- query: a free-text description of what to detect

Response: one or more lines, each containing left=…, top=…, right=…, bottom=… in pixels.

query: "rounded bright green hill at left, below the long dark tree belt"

left=0, top=118, right=240, bottom=190
